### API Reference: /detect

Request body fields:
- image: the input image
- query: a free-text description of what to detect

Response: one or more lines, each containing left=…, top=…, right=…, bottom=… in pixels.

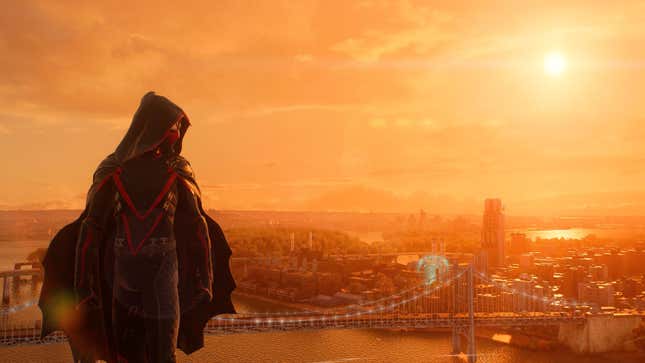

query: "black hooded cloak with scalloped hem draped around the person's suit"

left=38, top=92, right=235, bottom=361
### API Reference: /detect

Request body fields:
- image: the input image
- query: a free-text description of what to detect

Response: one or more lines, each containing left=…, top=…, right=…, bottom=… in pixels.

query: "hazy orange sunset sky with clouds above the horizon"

left=0, top=0, right=645, bottom=215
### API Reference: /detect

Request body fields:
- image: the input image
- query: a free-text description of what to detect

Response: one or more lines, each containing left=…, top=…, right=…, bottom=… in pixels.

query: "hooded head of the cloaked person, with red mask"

left=114, top=92, right=190, bottom=163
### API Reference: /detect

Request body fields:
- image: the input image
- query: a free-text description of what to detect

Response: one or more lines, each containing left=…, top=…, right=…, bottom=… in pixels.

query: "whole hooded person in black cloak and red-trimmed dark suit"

left=38, top=92, right=235, bottom=363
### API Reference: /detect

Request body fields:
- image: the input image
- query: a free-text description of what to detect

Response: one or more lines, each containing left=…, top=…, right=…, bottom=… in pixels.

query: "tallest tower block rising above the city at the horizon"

left=482, top=199, right=505, bottom=267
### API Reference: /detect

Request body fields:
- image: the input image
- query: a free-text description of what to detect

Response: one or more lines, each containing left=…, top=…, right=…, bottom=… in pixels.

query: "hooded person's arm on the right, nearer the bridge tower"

left=176, top=176, right=213, bottom=300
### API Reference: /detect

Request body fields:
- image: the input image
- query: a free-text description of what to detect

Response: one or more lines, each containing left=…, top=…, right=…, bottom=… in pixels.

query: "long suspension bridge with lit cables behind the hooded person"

left=0, top=265, right=628, bottom=362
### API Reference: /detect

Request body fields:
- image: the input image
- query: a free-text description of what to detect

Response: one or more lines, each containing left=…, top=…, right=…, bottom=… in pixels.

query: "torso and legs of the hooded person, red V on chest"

left=113, top=153, right=180, bottom=361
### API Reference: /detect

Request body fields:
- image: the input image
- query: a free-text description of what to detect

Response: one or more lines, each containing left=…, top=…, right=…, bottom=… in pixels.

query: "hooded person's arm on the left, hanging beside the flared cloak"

left=74, top=176, right=116, bottom=304
